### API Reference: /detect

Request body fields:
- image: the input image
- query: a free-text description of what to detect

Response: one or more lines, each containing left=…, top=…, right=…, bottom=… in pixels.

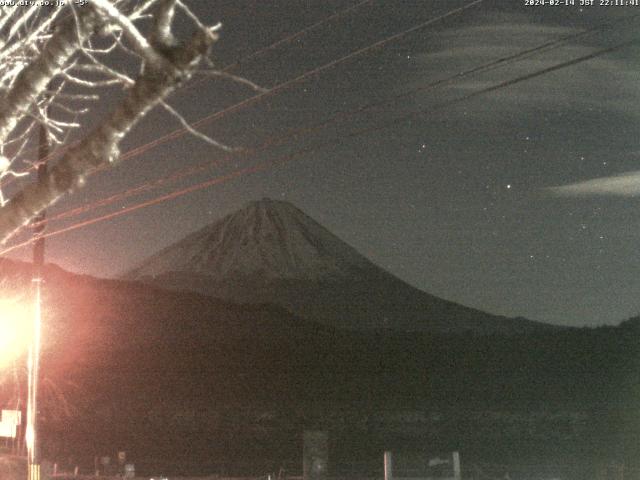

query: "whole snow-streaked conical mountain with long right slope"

left=123, top=199, right=554, bottom=334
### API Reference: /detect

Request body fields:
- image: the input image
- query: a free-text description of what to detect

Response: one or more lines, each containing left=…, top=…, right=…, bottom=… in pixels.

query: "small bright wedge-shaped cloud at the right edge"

left=546, top=170, right=640, bottom=197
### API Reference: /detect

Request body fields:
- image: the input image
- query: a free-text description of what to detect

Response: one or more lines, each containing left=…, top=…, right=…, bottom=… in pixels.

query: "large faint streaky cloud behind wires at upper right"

left=415, top=14, right=640, bottom=117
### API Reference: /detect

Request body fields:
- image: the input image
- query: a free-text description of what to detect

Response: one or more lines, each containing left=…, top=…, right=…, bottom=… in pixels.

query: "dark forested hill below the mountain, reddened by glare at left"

left=0, top=260, right=640, bottom=473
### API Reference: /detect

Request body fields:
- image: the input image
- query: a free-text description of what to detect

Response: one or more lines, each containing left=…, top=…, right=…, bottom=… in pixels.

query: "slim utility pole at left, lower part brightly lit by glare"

left=26, top=119, right=49, bottom=480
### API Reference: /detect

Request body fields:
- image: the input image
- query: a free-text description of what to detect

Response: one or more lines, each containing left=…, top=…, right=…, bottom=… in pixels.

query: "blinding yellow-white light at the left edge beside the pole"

left=0, top=298, right=32, bottom=368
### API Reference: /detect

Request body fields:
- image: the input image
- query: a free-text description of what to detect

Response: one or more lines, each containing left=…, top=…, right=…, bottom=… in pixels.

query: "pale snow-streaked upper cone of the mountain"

left=127, top=198, right=370, bottom=281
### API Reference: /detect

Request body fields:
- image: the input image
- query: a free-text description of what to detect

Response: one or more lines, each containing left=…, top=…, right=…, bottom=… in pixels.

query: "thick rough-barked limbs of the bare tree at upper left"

left=0, top=0, right=217, bottom=243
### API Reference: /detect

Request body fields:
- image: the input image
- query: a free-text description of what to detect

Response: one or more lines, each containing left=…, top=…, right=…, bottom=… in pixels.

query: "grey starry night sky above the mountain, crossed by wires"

left=5, top=0, right=640, bottom=326
